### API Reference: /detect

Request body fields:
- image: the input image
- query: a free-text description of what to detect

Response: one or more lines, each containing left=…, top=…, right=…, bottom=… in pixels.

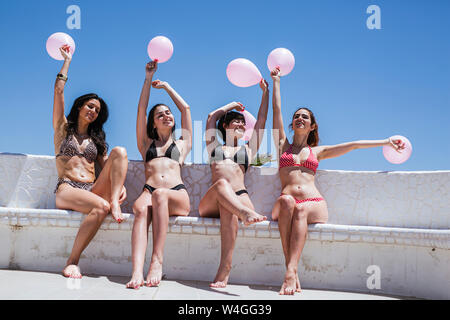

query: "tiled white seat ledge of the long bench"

left=0, top=207, right=450, bottom=249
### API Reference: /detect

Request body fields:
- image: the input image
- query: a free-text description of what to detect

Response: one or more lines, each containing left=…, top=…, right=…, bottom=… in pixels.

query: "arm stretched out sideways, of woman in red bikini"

left=314, top=138, right=405, bottom=161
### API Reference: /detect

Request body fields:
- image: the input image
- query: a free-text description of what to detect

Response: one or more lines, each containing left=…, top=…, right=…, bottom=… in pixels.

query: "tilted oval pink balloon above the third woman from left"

left=227, top=58, right=262, bottom=87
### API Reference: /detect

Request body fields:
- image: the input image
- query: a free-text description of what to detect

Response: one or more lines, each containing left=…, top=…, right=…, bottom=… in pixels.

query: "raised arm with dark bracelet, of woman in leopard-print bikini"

left=53, top=45, right=72, bottom=131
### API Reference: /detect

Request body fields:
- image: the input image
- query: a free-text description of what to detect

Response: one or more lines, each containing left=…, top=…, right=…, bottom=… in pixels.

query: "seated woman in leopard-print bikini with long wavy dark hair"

left=53, top=46, right=128, bottom=278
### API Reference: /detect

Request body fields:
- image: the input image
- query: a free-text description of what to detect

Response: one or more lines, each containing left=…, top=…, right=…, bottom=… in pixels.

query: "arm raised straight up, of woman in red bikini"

left=270, top=68, right=289, bottom=156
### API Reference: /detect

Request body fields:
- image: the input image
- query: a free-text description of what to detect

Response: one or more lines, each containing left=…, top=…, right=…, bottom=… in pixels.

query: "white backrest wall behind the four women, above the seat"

left=0, top=154, right=450, bottom=229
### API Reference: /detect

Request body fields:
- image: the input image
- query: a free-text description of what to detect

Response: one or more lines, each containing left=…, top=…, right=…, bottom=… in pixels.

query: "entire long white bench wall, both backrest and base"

left=0, top=154, right=450, bottom=299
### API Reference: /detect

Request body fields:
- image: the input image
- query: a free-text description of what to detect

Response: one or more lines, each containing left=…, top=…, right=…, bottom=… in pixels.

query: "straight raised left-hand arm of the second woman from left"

left=136, top=61, right=158, bottom=157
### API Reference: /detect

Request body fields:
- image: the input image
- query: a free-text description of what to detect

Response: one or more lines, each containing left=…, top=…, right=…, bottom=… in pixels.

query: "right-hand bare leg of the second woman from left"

left=147, top=188, right=190, bottom=287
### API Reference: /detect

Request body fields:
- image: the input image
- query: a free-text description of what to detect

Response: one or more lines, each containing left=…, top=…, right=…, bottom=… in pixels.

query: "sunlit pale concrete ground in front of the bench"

left=0, top=270, right=403, bottom=300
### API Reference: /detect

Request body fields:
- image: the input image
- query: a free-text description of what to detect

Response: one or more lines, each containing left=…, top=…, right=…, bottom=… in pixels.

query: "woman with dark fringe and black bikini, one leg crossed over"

left=198, top=80, right=269, bottom=288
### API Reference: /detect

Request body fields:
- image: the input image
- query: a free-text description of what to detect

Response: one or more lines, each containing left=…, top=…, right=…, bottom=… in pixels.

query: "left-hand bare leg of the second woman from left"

left=126, top=190, right=152, bottom=289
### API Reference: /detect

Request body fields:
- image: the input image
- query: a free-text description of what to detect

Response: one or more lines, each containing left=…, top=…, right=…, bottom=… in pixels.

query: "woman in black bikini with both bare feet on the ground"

left=126, top=62, right=192, bottom=289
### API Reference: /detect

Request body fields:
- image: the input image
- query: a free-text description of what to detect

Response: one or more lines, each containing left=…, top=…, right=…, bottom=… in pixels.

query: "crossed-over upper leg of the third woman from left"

left=198, top=179, right=267, bottom=225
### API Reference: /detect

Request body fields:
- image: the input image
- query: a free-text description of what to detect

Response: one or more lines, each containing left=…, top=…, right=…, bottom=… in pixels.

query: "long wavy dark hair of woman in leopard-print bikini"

left=66, top=93, right=109, bottom=155
